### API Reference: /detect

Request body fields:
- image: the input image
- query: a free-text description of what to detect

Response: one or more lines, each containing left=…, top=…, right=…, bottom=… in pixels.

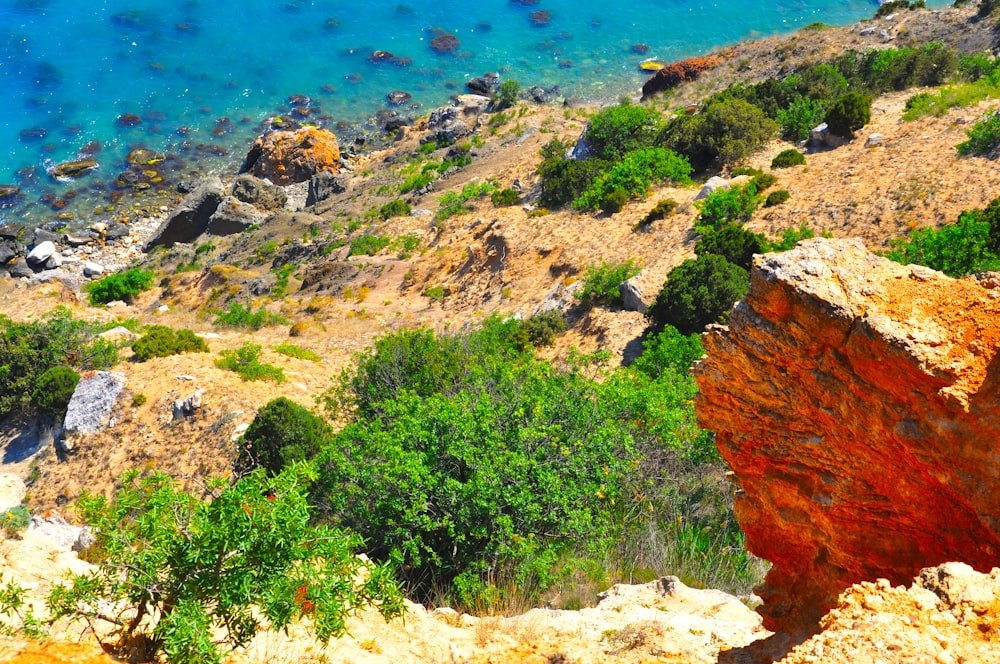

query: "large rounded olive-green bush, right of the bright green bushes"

left=664, top=99, right=778, bottom=171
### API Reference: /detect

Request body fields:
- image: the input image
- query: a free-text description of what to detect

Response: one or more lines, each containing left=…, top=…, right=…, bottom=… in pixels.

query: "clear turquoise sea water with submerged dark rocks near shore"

left=0, top=0, right=946, bottom=228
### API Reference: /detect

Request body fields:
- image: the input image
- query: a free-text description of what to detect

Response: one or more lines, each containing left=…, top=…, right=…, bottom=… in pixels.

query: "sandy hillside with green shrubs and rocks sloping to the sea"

left=0, top=1, right=1000, bottom=663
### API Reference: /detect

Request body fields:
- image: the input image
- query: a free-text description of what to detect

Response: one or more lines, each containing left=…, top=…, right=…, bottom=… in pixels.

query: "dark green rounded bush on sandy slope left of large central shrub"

left=235, top=397, right=333, bottom=475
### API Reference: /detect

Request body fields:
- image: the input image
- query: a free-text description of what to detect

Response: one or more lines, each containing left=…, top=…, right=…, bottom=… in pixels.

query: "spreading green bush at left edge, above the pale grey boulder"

left=0, top=307, right=118, bottom=419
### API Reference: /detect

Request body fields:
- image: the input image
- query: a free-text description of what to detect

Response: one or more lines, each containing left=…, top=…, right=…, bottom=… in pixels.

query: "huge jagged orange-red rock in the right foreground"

left=695, top=240, right=1000, bottom=630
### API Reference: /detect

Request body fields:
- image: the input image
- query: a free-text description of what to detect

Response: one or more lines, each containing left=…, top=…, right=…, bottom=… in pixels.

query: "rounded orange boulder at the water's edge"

left=242, top=127, right=340, bottom=186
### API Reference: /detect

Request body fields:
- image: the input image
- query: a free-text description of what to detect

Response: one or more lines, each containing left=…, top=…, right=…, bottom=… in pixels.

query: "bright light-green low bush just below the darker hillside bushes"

left=573, top=148, right=691, bottom=212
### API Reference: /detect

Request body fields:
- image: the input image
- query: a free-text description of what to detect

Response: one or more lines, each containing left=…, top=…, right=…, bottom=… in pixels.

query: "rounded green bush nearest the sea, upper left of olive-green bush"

left=583, top=104, right=663, bottom=161
